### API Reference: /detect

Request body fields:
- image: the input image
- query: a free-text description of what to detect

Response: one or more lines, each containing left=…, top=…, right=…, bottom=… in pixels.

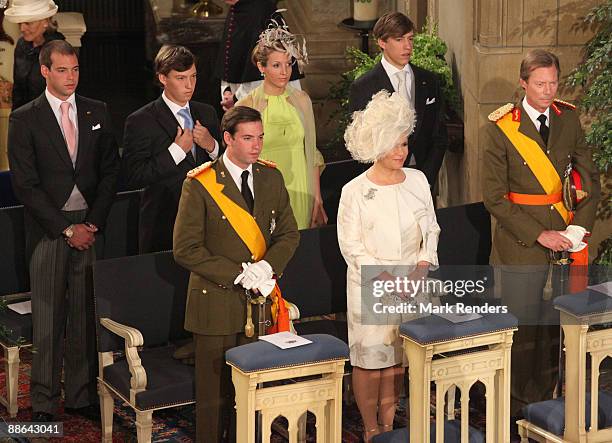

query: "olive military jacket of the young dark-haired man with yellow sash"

left=174, top=158, right=300, bottom=335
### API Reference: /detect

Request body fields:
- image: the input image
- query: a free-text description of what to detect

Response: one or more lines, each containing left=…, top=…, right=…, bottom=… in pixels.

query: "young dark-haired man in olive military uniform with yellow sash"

left=174, top=106, right=299, bottom=443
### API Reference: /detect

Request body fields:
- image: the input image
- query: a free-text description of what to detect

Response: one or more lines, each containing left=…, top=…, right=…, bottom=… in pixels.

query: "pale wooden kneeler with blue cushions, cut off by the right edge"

left=517, top=290, right=612, bottom=443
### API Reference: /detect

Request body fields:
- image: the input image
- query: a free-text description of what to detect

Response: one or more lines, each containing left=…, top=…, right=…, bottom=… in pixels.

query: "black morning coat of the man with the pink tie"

left=8, top=93, right=119, bottom=256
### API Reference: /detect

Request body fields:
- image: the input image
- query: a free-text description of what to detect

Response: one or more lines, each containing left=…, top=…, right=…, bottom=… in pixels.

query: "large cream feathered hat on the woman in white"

left=344, top=90, right=416, bottom=163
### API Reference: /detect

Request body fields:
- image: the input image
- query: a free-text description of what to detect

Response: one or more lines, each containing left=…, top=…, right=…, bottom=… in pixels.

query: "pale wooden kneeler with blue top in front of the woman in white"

left=373, top=314, right=517, bottom=443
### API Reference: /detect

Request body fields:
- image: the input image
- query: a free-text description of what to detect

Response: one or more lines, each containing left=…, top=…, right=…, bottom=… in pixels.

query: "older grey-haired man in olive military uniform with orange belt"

left=482, top=50, right=599, bottom=413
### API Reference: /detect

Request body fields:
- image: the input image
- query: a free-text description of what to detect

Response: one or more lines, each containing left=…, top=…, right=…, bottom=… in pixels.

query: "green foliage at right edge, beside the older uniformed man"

left=567, top=0, right=612, bottom=173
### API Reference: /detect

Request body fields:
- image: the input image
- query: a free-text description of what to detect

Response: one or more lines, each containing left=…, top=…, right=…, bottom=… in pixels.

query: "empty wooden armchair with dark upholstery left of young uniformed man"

left=94, top=252, right=195, bottom=443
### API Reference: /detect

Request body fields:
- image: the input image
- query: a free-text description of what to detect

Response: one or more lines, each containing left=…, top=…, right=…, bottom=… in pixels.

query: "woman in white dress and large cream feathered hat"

left=338, top=91, right=440, bottom=442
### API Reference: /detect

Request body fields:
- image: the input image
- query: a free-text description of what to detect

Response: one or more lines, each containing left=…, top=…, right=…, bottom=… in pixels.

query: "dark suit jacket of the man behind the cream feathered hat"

left=349, top=62, right=448, bottom=187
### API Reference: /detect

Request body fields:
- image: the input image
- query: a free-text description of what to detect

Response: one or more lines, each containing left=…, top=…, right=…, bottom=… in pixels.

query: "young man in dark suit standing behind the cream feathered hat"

left=349, top=12, right=448, bottom=189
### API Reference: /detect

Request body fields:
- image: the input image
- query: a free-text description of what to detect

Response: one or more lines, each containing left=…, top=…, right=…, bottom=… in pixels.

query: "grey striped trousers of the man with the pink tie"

left=30, top=211, right=101, bottom=414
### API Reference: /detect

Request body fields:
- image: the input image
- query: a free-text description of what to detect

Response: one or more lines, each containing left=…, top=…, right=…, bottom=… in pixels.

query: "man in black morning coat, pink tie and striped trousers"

left=8, top=40, right=119, bottom=421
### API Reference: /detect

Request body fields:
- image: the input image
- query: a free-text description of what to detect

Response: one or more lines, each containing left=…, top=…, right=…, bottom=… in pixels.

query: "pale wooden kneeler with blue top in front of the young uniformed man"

left=225, top=334, right=349, bottom=443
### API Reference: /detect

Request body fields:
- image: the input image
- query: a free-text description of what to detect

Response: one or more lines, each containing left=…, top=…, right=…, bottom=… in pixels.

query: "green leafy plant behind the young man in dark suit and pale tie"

left=326, top=19, right=460, bottom=148
